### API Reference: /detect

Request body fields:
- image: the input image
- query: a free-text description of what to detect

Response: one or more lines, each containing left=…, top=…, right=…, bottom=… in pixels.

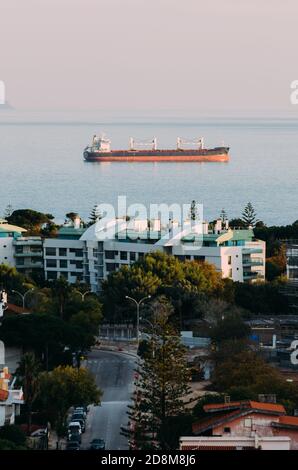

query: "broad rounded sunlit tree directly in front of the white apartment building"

left=102, top=252, right=224, bottom=320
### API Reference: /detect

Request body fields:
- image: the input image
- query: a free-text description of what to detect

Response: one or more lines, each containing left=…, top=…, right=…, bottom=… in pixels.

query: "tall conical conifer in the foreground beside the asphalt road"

left=123, top=305, right=190, bottom=450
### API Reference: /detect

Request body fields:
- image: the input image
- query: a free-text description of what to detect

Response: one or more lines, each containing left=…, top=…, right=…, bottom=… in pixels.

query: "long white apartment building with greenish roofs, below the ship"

left=44, top=219, right=266, bottom=292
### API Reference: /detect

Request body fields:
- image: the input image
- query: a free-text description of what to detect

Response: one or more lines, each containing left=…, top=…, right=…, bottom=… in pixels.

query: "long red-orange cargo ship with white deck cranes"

left=83, top=135, right=230, bottom=162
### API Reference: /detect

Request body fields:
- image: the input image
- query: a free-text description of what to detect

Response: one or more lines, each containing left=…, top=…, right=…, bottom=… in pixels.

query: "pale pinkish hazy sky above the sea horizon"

left=0, top=0, right=298, bottom=113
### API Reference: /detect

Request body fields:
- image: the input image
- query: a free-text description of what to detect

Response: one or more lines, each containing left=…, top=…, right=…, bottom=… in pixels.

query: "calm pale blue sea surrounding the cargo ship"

left=0, top=110, right=298, bottom=224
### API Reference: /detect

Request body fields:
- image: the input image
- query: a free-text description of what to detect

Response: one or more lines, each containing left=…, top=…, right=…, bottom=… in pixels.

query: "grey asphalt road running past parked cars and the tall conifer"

left=82, top=351, right=135, bottom=450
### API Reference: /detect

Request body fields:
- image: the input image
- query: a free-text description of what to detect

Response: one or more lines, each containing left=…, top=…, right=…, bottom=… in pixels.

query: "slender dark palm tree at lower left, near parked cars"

left=16, top=352, right=40, bottom=435
